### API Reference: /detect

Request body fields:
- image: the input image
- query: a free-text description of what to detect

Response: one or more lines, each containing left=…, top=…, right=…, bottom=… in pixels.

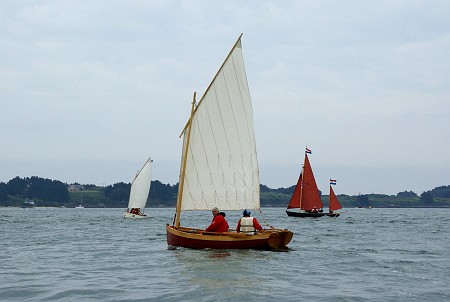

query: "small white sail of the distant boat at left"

left=128, top=158, right=152, bottom=209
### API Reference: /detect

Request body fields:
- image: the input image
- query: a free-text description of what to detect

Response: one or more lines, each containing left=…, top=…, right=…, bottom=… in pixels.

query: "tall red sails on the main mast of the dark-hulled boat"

left=288, top=154, right=323, bottom=211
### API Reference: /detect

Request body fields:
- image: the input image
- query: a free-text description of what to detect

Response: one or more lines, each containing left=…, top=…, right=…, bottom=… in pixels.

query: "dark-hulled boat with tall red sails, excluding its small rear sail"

left=286, top=148, right=337, bottom=217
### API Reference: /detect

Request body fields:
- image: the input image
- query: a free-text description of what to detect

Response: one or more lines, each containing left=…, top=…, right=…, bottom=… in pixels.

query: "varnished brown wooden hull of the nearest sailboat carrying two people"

left=166, top=224, right=293, bottom=250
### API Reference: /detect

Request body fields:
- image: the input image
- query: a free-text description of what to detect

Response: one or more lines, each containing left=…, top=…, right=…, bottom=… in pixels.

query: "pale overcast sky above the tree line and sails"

left=0, top=0, right=450, bottom=195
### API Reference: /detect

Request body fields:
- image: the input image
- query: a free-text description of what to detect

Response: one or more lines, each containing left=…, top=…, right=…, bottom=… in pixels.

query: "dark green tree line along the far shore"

left=0, top=176, right=450, bottom=208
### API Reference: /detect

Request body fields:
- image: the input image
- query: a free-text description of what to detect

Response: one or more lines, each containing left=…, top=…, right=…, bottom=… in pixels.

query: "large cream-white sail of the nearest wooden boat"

left=181, top=38, right=260, bottom=210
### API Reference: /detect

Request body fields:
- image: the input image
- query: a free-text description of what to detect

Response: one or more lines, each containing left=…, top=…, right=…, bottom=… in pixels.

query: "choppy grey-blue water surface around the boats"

left=0, top=208, right=450, bottom=301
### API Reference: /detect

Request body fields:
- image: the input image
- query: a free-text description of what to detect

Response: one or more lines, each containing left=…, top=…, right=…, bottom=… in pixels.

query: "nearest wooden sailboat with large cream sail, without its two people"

left=166, top=37, right=293, bottom=250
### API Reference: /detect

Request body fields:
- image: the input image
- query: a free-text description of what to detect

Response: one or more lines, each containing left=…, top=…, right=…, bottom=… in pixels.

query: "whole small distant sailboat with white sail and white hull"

left=123, top=158, right=153, bottom=219
